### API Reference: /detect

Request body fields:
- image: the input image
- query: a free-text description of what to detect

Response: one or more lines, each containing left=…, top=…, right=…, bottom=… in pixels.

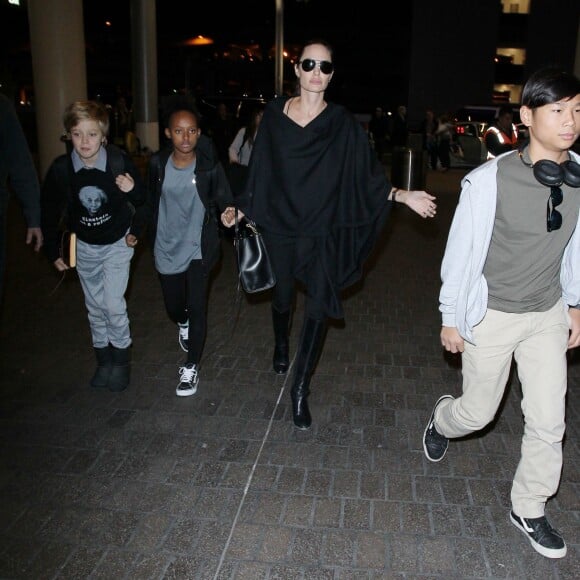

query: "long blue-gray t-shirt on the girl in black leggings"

left=153, top=157, right=205, bottom=274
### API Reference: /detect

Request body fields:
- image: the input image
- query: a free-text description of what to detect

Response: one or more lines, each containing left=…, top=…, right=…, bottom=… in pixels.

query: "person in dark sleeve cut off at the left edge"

left=0, top=93, right=43, bottom=300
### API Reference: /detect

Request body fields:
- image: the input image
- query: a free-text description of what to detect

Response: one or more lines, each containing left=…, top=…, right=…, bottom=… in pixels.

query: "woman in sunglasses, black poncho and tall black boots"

left=222, top=40, right=436, bottom=429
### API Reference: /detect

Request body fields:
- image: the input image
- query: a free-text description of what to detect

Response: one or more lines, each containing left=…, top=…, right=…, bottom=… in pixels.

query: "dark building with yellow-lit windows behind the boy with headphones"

left=407, top=0, right=580, bottom=128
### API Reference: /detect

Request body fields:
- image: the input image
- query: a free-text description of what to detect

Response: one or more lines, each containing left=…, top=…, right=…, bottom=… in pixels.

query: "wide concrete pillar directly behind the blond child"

left=28, top=0, right=87, bottom=179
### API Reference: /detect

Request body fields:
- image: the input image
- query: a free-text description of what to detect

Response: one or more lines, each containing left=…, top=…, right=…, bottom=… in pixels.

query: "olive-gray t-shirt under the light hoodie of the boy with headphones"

left=483, top=151, right=580, bottom=313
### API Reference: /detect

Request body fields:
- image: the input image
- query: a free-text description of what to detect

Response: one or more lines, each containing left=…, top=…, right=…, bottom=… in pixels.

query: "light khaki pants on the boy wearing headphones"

left=435, top=301, right=569, bottom=518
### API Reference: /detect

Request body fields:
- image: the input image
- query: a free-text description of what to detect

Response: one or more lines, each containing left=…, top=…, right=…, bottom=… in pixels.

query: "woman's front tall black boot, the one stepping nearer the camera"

left=290, top=318, right=326, bottom=429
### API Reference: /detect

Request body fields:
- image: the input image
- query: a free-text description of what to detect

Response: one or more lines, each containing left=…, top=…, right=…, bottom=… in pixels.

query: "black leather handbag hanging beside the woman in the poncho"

left=234, top=210, right=276, bottom=294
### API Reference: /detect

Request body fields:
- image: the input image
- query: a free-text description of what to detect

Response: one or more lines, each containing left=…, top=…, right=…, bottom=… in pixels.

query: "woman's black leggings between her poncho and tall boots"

left=264, top=233, right=326, bottom=320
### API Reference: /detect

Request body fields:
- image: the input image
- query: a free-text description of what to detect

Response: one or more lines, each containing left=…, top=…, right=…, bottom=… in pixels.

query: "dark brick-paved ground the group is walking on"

left=0, top=171, right=580, bottom=580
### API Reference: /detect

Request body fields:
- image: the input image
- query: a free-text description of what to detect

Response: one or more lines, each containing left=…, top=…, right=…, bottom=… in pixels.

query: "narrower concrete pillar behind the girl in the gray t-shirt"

left=131, top=0, right=159, bottom=151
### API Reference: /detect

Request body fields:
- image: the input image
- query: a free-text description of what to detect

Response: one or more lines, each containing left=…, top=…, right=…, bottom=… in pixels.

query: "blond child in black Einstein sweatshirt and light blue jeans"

left=42, top=101, right=145, bottom=391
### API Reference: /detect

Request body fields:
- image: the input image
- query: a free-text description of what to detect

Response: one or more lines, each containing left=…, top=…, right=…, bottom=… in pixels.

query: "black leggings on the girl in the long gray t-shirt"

left=159, top=260, right=209, bottom=364
